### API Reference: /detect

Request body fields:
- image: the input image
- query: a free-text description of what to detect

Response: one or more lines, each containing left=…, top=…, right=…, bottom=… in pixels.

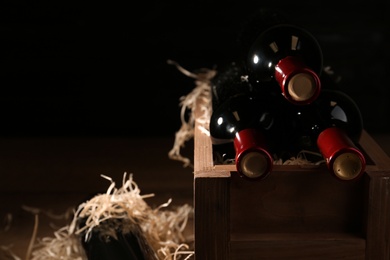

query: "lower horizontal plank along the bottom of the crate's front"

left=230, top=233, right=364, bottom=260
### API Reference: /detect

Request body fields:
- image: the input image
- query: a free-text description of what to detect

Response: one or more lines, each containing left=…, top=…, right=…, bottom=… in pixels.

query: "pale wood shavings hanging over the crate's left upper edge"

left=167, top=60, right=217, bottom=168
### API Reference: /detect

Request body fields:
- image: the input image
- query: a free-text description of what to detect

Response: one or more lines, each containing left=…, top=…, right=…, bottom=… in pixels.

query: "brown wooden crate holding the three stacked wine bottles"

left=194, top=100, right=390, bottom=260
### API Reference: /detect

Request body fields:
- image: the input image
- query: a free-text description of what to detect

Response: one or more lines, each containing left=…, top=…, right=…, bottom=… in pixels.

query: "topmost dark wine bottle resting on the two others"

left=240, top=10, right=323, bottom=105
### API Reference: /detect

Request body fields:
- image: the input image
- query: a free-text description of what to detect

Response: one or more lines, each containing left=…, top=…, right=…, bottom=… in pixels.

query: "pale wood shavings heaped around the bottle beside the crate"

left=0, top=173, right=194, bottom=260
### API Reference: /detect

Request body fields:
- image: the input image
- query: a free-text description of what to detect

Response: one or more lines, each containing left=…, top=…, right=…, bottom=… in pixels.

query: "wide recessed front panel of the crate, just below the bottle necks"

left=230, top=169, right=365, bottom=234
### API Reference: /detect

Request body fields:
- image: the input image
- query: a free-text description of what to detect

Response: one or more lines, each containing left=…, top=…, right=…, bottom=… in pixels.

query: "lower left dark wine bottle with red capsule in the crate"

left=209, top=88, right=289, bottom=180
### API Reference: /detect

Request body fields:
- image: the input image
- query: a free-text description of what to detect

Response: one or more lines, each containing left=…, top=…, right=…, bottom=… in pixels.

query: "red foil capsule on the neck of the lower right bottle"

left=317, top=127, right=366, bottom=181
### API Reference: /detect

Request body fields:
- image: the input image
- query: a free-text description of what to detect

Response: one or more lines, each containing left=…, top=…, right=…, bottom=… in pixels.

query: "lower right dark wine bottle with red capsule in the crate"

left=284, top=89, right=366, bottom=180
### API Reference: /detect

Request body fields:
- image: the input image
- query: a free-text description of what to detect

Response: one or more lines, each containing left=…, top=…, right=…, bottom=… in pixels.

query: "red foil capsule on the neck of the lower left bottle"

left=234, top=128, right=273, bottom=180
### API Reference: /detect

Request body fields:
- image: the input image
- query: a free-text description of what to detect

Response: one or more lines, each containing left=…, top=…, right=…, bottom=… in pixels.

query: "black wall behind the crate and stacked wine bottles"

left=0, top=1, right=390, bottom=136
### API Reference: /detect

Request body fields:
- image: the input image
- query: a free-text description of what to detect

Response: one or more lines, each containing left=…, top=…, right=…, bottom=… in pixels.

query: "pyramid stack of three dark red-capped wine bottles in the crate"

left=209, top=10, right=366, bottom=181
